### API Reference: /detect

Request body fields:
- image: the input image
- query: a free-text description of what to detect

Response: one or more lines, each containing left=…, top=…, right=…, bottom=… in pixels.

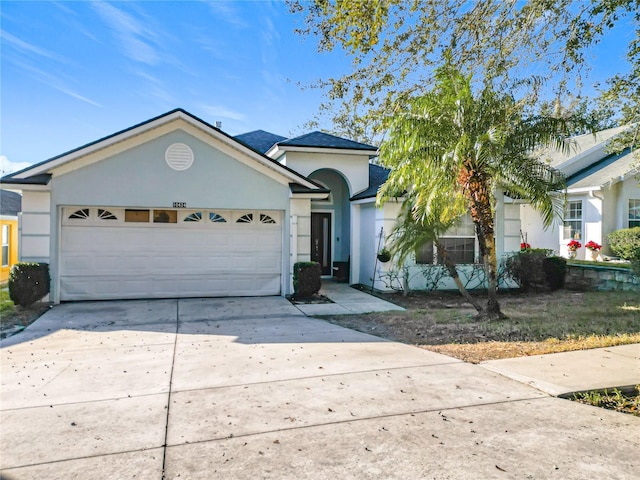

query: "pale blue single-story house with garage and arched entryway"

left=2, top=109, right=520, bottom=302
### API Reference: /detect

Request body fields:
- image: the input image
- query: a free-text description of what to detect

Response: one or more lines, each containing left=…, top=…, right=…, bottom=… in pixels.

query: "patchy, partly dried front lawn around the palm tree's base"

left=327, top=291, right=640, bottom=363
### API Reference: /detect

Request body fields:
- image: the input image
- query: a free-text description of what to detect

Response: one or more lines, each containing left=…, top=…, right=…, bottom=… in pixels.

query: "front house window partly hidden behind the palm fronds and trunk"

left=415, top=215, right=476, bottom=265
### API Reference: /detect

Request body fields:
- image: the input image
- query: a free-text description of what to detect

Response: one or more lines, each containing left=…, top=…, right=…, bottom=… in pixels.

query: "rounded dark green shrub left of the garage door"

left=9, top=263, right=51, bottom=307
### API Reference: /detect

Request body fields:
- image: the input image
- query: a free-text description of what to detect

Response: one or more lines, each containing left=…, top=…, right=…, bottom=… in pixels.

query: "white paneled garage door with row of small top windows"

left=60, top=207, right=283, bottom=300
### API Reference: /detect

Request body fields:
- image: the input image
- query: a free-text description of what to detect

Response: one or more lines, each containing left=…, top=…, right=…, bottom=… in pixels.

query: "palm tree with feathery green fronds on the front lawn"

left=378, top=66, right=569, bottom=319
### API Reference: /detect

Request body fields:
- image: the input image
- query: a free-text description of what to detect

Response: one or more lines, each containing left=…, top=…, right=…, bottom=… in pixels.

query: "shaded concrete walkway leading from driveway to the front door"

left=296, top=279, right=404, bottom=316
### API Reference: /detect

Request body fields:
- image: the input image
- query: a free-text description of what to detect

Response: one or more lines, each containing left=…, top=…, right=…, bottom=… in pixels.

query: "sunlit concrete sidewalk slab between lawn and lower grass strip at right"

left=480, top=343, right=640, bottom=397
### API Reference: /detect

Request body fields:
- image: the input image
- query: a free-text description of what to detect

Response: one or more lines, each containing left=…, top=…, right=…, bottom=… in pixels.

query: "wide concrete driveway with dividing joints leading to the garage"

left=0, top=297, right=640, bottom=480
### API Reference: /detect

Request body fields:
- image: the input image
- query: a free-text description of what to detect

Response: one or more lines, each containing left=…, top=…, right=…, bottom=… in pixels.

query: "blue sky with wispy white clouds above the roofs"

left=0, top=0, right=628, bottom=173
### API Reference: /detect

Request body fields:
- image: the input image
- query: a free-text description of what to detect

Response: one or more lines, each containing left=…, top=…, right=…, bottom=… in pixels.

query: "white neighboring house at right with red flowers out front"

left=521, top=127, right=640, bottom=259
